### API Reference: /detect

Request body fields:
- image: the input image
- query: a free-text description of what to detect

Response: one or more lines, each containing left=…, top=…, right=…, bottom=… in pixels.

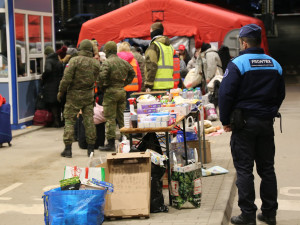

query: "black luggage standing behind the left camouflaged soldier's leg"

left=75, top=114, right=105, bottom=149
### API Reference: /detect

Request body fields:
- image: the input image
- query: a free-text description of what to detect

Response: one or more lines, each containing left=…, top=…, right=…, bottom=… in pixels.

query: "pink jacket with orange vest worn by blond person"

left=117, top=52, right=142, bottom=91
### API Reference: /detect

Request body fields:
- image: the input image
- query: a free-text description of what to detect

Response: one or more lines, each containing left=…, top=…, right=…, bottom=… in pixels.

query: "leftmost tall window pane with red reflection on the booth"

left=15, top=13, right=27, bottom=77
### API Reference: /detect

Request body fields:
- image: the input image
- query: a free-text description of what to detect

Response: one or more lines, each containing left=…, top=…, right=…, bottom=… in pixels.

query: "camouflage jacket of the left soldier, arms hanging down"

left=59, top=50, right=100, bottom=101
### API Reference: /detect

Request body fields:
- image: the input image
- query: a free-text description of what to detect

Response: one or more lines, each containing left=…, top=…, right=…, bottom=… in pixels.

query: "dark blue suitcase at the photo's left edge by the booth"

left=0, top=103, right=12, bottom=148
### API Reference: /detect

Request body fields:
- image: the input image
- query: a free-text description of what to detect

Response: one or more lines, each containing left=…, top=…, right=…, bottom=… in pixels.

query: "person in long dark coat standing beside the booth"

left=42, top=46, right=63, bottom=127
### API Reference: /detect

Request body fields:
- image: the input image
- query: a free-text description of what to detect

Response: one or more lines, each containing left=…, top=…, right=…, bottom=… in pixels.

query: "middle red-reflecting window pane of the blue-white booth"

left=28, top=15, right=42, bottom=54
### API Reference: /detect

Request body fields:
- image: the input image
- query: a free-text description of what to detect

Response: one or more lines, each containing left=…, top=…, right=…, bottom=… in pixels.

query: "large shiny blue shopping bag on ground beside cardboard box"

left=43, top=188, right=106, bottom=225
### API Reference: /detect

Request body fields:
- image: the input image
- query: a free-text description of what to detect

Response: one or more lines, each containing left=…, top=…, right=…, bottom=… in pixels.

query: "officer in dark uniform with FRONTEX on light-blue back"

left=219, top=24, right=285, bottom=225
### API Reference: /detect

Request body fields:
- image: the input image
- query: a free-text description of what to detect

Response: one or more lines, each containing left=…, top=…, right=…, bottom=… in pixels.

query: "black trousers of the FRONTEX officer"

left=230, top=117, right=278, bottom=218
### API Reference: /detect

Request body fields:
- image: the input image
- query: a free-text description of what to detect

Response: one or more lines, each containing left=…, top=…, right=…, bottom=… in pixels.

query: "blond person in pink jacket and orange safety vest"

left=117, top=41, right=142, bottom=92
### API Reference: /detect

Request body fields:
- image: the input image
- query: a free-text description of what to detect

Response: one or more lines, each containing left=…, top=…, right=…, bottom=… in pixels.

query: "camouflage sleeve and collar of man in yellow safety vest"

left=144, top=36, right=171, bottom=89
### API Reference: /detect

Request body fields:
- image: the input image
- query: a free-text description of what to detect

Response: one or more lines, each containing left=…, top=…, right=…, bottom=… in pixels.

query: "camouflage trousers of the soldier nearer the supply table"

left=103, top=88, right=126, bottom=140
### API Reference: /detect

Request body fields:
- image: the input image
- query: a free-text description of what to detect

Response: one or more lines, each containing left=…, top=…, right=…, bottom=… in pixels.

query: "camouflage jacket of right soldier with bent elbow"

left=98, top=54, right=135, bottom=91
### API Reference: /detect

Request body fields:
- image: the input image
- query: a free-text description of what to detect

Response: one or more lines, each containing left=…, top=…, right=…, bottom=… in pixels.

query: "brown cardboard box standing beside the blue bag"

left=104, top=152, right=151, bottom=218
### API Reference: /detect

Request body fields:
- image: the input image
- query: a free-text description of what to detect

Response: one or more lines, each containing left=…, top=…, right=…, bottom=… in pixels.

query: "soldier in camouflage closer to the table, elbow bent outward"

left=99, top=41, right=135, bottom=151
